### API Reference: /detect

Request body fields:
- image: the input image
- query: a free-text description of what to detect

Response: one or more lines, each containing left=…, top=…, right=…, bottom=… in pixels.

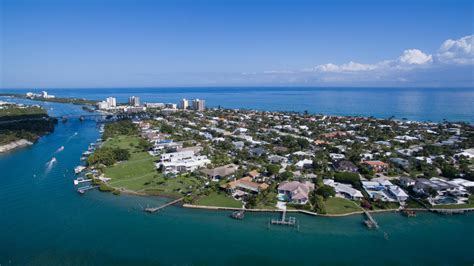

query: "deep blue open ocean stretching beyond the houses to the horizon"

left=0, top=87, right=474, bottom=123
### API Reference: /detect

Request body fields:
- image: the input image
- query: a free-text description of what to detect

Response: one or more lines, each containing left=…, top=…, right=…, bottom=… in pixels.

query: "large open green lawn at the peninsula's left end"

left=104, top=136, right=201, bottom=196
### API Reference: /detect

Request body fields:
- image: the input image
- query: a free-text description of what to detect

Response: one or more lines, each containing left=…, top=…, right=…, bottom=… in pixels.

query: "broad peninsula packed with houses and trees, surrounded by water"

left=78, top=96, right=474, bottom=216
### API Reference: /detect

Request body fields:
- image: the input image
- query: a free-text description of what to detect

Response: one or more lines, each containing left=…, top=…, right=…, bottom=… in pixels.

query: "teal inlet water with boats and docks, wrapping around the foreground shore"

left=0, top=95, right=474, bottom=265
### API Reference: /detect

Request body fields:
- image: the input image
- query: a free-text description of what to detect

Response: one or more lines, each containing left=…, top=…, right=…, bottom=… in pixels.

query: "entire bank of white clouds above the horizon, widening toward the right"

left=259, top=35, right=474, bottom=86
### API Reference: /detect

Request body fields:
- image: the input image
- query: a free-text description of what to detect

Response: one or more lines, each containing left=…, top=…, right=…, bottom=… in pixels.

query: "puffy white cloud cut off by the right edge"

left=438, top=35, right=474, bottom=64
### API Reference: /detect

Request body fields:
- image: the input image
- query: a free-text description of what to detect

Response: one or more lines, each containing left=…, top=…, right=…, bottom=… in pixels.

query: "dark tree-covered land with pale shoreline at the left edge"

left=0, top=102, right=57, bottom=153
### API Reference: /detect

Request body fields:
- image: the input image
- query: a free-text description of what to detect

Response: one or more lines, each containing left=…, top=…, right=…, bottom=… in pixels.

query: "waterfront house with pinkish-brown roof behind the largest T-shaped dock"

left=278, top=181, right=314, bottom=204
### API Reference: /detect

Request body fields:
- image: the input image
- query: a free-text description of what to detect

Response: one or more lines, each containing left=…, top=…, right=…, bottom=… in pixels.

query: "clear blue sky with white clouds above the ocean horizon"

left=0, top=0, right=474, bottom=88
